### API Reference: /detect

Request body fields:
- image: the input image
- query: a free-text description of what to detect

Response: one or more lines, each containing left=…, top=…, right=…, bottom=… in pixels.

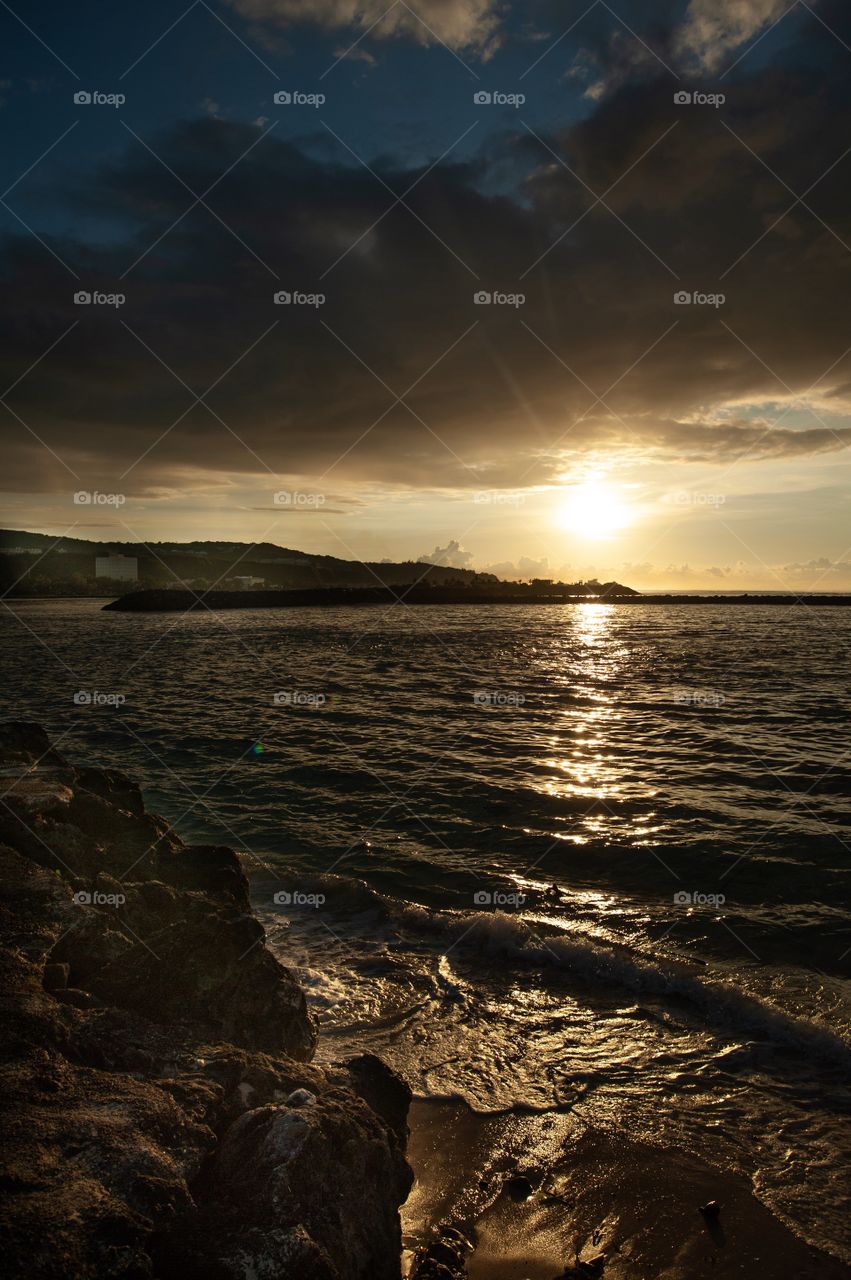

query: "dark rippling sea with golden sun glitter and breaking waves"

left=0, top=600, right=851, bottom=1260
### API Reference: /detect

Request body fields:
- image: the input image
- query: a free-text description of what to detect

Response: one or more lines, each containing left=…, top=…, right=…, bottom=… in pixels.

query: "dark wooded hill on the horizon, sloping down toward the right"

left=0, top=529, right=632, bottom=596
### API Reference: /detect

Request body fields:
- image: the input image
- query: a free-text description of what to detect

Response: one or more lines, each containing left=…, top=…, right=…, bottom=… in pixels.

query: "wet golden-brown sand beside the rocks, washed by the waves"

left=402, top=1101, right=851, bottom=1280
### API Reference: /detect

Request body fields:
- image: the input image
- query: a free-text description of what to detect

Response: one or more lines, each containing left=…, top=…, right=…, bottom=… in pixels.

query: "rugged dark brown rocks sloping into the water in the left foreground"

left=0, top=723, right=411, bottom=1280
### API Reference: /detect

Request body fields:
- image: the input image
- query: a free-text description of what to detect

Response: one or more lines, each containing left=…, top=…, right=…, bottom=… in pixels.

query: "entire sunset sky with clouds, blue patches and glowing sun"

left=0, top=0, right=851, bottom=591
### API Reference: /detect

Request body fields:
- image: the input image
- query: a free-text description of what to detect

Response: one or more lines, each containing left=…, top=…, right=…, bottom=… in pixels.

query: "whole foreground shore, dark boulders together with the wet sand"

left=0, top=723, right=851, bottom=1280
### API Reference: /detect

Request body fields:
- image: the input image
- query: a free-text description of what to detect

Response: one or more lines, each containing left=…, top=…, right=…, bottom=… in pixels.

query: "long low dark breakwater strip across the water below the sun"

left=104, top=586, right=851, bottom=613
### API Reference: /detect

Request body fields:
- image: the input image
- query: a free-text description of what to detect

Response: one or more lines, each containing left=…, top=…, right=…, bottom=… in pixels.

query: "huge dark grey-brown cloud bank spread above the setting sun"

left=0, top=0, right=851, bottom=503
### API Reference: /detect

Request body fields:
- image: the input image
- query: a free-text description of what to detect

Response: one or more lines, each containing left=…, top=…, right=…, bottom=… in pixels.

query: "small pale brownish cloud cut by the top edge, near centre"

left=228, top=0, right=500, bottom=52
